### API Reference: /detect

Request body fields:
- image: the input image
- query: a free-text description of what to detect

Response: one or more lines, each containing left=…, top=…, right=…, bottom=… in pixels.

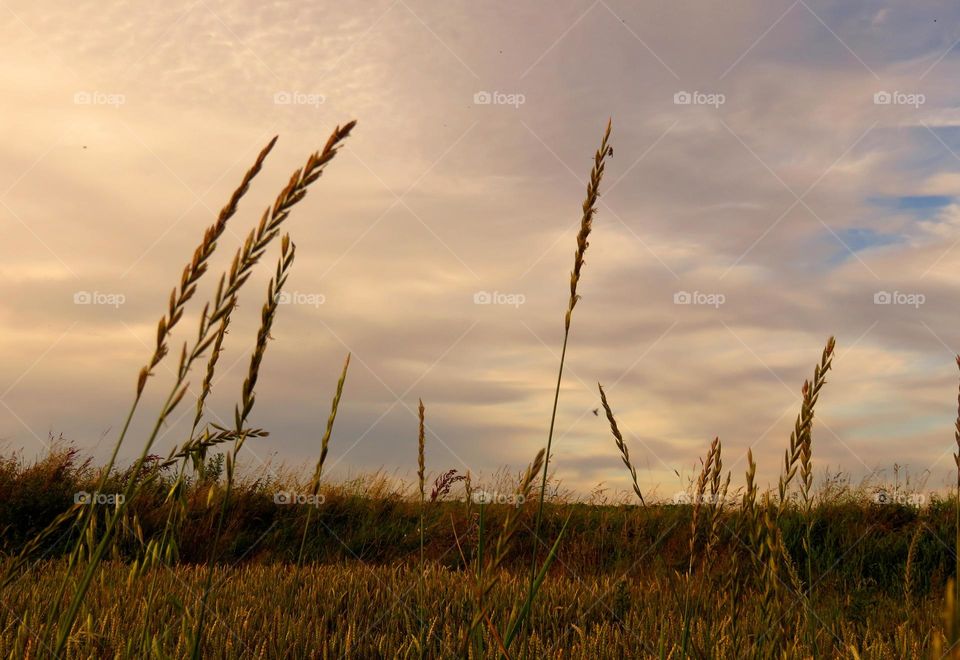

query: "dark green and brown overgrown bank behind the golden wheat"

left=0, top=444, right=955, bottom=595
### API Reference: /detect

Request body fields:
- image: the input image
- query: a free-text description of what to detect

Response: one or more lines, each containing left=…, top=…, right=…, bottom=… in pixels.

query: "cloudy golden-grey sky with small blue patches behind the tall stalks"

left=0, top=0, right=960, bottom=498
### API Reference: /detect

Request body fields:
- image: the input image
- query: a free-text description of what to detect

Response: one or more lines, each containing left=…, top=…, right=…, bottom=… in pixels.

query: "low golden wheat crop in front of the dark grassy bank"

left=0, top=562, right=940, bottom=658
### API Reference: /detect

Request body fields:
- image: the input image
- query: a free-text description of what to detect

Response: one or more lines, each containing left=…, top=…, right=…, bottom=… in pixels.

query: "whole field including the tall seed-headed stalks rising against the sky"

left=0, top=122, right=960, bottom=658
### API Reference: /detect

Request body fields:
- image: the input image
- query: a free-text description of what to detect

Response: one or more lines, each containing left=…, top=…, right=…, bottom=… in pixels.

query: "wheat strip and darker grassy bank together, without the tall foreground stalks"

left=0, top=447, right=955, bottom=658
